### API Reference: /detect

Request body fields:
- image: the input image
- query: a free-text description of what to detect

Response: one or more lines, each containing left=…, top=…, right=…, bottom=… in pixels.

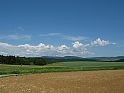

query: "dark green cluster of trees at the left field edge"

left=0, top=55, right=47, bottom=65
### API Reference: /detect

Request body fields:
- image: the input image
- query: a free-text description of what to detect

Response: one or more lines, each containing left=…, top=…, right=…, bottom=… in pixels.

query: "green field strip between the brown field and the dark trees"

left=0, top=61, right=124, bottom=75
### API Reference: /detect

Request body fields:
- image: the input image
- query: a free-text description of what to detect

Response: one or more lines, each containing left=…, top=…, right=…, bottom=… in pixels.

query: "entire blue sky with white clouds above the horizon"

left=0, top=0, right=124, bottom=57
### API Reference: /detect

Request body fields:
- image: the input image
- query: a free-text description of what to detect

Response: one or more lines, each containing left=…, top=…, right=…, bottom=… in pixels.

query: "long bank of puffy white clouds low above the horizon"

left=0, top=38, right=115, bottom=57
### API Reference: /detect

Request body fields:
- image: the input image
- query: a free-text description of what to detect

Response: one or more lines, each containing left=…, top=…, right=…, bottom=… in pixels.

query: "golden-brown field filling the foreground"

left=0, top=70, right=124, bottom=93
